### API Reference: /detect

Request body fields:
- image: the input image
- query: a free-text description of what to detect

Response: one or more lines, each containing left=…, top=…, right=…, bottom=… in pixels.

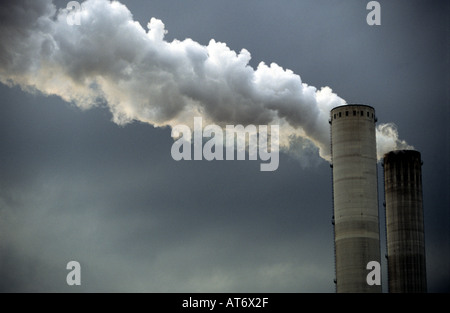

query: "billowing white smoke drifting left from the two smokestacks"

left=0, top=0, right=414, bottom=160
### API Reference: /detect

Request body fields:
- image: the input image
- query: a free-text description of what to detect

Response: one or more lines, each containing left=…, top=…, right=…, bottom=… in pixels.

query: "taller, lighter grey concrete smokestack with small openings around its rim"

left=330, top=105, right=381, bottom=292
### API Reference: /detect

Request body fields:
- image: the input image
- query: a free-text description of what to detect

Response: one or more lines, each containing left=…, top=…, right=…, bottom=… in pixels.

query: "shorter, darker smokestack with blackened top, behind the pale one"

left=383, top=150, right=427, bottom=293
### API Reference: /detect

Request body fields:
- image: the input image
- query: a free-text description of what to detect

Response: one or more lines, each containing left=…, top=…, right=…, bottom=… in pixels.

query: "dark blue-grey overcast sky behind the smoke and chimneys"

left=0, top=0, right=450, bottom=292
